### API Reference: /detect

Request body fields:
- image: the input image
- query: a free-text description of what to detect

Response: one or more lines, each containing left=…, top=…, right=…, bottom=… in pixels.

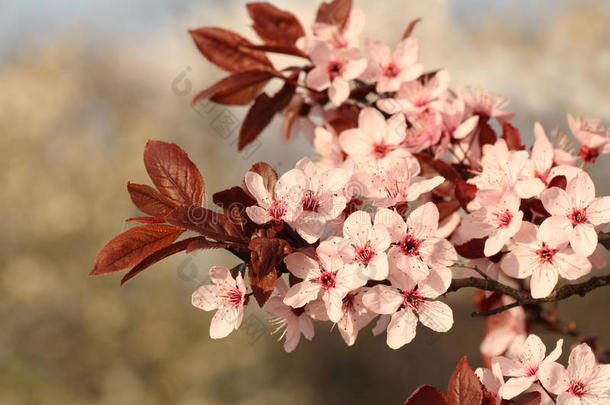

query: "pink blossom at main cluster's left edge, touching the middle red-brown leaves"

left=245, top=169, right=306, bottom=225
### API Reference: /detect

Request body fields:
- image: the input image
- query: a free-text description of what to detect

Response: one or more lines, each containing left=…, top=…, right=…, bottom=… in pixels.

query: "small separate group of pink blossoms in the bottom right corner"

left=475, top=334, right=610, bottom=405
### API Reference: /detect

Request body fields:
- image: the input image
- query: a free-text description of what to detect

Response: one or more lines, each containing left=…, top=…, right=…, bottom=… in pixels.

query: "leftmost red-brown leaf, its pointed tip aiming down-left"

left=90, top=225, right=184, bottom=275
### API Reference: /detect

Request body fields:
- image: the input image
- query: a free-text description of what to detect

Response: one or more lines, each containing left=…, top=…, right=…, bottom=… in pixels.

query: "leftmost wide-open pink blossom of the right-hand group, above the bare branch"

left=461, top=192, right=523, bottom=257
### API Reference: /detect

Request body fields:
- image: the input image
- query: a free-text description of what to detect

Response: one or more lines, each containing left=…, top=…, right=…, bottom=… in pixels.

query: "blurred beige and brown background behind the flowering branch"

left=0, top=0, right=610, bottom=405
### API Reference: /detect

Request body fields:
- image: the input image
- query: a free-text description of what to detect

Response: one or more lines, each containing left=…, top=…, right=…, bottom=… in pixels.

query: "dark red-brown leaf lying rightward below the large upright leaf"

left=165, top=206, right=247, bottom=243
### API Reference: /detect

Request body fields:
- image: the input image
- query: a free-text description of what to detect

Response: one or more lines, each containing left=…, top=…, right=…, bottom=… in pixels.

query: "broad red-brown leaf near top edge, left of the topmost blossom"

left=246, top=3, right=305, bottom=46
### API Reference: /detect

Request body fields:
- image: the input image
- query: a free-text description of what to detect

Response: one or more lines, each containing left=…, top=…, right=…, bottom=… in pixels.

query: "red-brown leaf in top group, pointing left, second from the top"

left=189, top=27, right=273, bottom=73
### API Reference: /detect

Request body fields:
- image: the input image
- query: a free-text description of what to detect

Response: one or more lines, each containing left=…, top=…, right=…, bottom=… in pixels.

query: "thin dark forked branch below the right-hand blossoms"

left=447, top=275, right=610, bottom=316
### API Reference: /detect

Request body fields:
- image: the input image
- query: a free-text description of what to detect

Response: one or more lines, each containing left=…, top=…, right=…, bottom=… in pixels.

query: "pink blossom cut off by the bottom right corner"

left=538, top=343, right=610, bottom=405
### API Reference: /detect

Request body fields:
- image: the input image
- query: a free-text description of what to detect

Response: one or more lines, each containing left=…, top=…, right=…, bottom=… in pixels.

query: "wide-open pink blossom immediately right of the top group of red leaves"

left=306, top=42, right=367, bottom=105
